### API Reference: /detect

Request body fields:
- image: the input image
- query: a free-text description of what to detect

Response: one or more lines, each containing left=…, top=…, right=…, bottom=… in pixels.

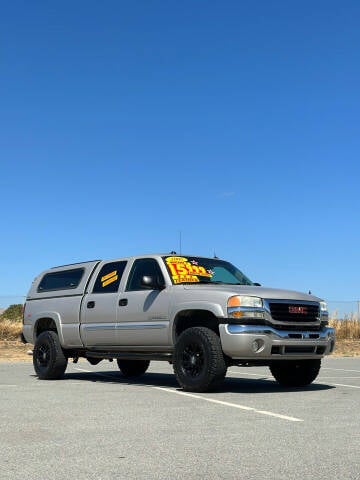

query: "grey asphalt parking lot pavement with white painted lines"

left=0, top=357, right=360, bottom=480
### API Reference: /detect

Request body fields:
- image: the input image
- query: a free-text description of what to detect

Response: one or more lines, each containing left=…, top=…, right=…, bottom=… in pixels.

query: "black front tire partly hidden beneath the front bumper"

left=270, top=360, right=321, bottom=387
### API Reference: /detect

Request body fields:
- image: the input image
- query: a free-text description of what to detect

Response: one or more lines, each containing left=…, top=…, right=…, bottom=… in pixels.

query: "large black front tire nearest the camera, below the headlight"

left=173, top=327, right=227, bottom=392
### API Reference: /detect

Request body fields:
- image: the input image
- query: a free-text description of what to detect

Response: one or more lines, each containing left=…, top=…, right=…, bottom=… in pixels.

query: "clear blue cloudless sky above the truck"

left=0, top=0, right=360, bottom=306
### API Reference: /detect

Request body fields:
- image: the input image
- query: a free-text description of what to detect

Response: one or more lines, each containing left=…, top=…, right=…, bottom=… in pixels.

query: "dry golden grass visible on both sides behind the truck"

left=0, top=318, right=360, bottom=362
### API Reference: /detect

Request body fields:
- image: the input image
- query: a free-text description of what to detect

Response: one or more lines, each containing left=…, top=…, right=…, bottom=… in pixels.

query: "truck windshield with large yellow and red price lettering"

left=163, top=256, right=253, bottom=285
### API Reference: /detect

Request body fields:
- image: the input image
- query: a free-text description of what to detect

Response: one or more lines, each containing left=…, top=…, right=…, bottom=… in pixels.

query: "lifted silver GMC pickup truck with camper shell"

left=23, top=252, right=335, bottom=392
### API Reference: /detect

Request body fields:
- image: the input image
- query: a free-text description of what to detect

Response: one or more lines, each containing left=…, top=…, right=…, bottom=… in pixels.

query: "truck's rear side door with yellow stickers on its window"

left=80, top=260, right=127, bottom=347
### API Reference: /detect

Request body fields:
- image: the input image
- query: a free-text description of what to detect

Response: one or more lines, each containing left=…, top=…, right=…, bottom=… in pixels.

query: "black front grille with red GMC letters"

left=269, top=302, right=319, bottom=322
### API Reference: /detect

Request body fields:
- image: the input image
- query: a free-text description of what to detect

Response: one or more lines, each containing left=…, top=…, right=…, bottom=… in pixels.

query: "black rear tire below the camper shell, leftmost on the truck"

left=33, top=330, right=68, bottom=380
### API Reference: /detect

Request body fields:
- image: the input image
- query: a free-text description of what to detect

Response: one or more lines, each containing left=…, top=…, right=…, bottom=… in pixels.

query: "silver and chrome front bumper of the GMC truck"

left=219, top=324, right=335, bottom=360
